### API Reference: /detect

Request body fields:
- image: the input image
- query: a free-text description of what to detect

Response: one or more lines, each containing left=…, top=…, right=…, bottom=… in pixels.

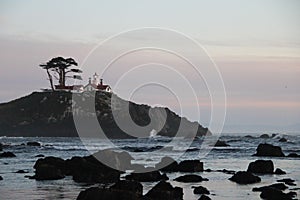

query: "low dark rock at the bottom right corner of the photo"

left=260, top=187, right=295, bottom=200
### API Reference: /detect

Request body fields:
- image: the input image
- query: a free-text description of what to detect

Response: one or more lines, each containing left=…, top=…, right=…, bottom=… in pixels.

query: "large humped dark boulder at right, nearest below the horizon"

left=254, top=143, right=284, bottom=157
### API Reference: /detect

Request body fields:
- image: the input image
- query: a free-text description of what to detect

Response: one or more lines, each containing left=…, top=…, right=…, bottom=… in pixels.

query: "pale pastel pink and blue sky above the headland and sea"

left=0, top=0, right=300, bottom=132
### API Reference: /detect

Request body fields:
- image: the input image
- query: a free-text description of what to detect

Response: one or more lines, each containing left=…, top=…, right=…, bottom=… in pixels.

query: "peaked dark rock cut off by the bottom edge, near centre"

left=145, top=181, right=183, bottom=200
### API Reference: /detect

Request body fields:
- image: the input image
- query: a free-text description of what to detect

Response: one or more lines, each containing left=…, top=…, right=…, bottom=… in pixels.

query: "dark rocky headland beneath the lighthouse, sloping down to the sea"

left=0, top=92, right=210, bottom=138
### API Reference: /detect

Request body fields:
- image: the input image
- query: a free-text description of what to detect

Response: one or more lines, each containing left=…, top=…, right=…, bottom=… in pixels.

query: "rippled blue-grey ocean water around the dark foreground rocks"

left=0, top=134, right=300, bottom=200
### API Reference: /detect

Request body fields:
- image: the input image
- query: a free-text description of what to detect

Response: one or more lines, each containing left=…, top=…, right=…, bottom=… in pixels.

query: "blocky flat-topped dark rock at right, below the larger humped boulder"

left=247, top=160, right=274, bottom=174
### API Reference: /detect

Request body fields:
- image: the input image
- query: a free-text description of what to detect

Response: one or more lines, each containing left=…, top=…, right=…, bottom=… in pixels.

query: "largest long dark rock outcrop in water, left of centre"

left=32, top=150, right=124, bottom=183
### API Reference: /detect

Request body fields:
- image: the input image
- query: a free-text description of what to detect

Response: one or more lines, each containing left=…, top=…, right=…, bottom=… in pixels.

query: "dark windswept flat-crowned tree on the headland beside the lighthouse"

left=39, top=57, right=82, bottom=91
